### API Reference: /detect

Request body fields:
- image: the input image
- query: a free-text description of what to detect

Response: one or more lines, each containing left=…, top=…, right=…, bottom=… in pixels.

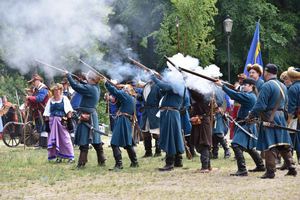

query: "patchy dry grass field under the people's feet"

left=0, top=137, right=300, bottom=200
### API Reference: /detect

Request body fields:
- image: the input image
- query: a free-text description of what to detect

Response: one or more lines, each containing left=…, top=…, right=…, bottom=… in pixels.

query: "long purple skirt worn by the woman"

left=47, top=116, right=74, bottom=160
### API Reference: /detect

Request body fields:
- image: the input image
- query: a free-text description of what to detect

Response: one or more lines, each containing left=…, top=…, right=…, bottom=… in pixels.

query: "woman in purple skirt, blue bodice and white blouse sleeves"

left=44, top=83, right=75, bottom=163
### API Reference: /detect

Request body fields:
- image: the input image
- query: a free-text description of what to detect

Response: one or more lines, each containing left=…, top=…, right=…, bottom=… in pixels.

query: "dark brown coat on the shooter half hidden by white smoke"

left=189, top=90, right=212, bottom=146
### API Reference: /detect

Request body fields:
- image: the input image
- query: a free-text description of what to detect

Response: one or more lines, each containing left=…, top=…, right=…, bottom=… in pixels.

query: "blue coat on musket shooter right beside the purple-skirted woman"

left=66, top=73, right=102, bottom=146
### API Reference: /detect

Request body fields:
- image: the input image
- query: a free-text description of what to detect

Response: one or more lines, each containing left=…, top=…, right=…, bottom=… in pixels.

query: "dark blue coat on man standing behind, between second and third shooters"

left=138, top=83, right=162, bottom=130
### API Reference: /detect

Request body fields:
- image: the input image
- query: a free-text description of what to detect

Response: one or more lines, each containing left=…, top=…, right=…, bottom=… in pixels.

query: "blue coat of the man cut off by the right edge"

left=288, top=81, right=300, bottom=151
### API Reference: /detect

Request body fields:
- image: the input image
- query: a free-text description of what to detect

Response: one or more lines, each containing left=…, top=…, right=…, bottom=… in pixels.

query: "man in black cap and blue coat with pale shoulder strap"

left=245, top=64, right=297, bottom=179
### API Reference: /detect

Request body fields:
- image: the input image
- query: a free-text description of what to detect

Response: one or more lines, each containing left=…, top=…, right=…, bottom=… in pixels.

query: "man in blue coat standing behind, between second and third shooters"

left=138, top=80, right=162, bottom=158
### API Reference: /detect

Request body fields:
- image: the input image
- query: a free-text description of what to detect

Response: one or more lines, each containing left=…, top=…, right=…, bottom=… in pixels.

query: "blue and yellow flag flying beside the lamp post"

left=244, top=19, right=263, bottom=78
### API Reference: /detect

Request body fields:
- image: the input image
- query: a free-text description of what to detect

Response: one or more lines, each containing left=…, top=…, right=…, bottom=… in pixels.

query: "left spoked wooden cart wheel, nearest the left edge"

left=2, top=122, right=21, bottom=147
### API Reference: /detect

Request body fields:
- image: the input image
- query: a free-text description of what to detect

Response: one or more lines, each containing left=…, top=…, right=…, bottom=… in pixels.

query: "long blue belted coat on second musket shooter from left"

left=105, top=81, right=135, bottom=147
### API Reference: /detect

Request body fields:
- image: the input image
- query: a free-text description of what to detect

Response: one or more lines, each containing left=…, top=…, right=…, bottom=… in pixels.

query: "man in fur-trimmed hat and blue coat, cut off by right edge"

left=287, top=67, right=300, bottom=164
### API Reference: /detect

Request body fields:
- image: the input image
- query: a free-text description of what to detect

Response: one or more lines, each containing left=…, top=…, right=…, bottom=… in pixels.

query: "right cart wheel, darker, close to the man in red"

left=21, top=121, right=39, bottom=146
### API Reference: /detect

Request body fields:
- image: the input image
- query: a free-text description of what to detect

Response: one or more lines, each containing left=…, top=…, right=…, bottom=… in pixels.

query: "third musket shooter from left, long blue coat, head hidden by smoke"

left=150, top=72, right=185, bottom=171
